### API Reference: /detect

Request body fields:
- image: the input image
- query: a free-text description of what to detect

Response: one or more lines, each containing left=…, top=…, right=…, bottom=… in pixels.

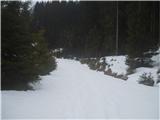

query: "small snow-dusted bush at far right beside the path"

left=139, top=73, right=154, bottom=86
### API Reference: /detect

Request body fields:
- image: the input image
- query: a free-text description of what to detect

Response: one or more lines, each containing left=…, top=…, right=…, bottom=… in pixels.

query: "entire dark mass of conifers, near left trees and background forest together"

left=1, top=1, right=160, bottom=89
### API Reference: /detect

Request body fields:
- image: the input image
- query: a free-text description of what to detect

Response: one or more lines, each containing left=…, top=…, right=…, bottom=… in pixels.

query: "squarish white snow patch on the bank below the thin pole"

left=105, top=56, right=128, bottom=75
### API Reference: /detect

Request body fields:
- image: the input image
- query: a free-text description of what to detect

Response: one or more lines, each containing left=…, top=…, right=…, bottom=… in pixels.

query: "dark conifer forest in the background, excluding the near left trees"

left=33, top=1, right=159, bottom=57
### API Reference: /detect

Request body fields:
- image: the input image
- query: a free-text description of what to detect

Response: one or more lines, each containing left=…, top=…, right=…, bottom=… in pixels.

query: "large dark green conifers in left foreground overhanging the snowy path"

left=1, top=1, right=55, bottom=90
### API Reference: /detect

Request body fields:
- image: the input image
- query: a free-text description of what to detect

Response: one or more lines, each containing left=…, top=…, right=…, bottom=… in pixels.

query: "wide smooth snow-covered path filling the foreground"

left=2, top=59, right=159, bottom=119
